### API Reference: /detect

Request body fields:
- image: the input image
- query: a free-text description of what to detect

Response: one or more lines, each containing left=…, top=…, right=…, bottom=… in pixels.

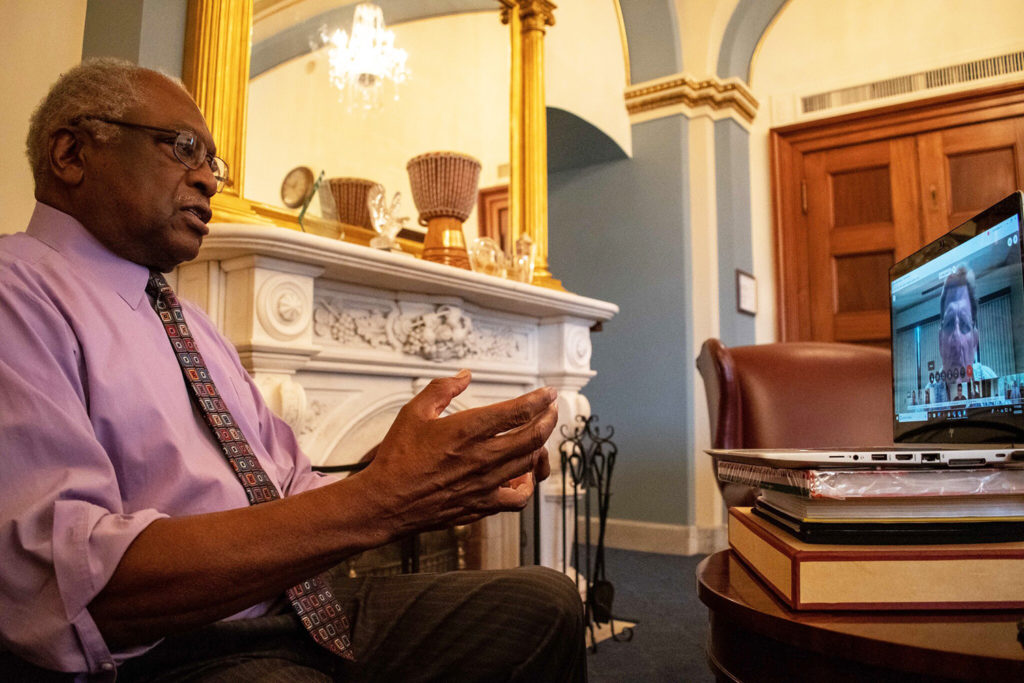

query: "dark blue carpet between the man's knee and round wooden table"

left=588, top=548, right=715, bottom=683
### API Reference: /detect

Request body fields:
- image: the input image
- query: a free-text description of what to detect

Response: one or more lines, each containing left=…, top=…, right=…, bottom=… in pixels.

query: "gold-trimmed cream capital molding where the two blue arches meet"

left=625, top=74, right=760, bottom=127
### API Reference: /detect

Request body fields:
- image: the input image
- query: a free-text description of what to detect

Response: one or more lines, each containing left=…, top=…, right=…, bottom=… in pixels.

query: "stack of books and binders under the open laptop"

left=719, top=462, right=1024, bottom=609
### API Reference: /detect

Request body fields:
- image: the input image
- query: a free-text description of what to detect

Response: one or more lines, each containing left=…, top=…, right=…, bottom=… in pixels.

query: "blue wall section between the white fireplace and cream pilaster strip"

left=548, top=116, right=694, bottom=524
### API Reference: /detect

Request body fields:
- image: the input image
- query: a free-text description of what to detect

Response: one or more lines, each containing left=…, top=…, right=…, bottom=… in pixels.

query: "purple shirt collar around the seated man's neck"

left=26, top=202, right=150, bottom=309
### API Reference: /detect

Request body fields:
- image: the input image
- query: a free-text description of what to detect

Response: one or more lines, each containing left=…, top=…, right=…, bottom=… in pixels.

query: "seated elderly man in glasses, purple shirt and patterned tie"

left=0, top=60, right=586, bottom=681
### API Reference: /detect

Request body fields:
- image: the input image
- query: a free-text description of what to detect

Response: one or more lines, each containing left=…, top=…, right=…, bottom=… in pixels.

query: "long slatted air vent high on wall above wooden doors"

left=800, top=51, right=1024, bottom=114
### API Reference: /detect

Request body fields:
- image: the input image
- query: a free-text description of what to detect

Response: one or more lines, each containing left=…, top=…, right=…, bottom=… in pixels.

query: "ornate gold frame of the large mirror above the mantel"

left=176, top=0, right=562, bottom=289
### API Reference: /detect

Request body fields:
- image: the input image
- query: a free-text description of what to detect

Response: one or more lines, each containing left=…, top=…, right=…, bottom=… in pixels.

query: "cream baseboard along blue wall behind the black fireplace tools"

left=580, top=518, right=729, bottom=555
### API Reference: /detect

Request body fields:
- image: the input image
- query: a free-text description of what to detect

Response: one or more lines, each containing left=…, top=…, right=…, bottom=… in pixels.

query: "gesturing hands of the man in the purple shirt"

left=349, top=370, right=558, bottom=535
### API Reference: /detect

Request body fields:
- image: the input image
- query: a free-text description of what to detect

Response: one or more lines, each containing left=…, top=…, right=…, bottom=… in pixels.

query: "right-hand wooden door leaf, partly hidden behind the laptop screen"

left=918, top=118, right=1024, bottom=244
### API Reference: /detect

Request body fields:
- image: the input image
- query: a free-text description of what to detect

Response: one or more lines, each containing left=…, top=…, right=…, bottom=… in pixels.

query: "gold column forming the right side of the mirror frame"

left=510, top=0, right=565, bottom=291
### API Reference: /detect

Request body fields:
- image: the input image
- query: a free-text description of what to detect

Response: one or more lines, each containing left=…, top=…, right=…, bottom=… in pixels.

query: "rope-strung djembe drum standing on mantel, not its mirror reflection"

left=406, top=152, right=480, bottom=270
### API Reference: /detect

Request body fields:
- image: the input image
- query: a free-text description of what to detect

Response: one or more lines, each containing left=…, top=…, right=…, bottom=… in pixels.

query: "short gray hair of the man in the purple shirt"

left=26, top=57, right=184, bottom=188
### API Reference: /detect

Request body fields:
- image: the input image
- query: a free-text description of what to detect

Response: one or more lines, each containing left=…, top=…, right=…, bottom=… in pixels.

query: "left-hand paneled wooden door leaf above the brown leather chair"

left=804, top=136, right=921, bottom=343
